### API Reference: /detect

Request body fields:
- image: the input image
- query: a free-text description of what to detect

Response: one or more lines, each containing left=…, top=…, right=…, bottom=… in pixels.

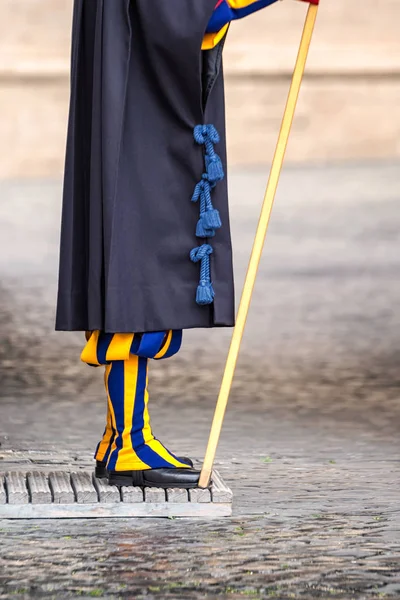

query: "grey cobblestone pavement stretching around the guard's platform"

left=0, top=165, right=400, bottom=600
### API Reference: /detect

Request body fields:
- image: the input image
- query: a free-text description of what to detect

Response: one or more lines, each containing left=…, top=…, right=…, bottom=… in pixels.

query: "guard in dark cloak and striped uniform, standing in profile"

left=56, top=0, right=282, bottom=488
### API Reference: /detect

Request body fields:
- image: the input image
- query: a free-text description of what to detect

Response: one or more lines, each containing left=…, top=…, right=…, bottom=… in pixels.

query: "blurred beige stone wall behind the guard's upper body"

left=0, top=0, right=400, bottom=177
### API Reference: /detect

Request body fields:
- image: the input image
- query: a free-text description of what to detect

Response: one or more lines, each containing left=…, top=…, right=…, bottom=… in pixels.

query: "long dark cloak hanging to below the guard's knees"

left=56, top=0, right=234, bottom=333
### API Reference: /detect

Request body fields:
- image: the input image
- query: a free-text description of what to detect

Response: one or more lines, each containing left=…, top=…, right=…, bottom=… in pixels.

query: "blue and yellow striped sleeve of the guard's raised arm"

left=203, top=0, right=277, bottom=50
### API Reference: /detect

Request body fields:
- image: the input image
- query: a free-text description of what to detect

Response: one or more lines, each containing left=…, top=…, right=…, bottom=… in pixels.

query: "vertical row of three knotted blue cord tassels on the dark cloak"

left=190, top=125, right=224, bottom=305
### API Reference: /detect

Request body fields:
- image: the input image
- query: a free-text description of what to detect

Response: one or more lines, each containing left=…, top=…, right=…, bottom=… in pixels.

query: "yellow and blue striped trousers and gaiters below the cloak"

left=81, top=331, right=188, bottom=471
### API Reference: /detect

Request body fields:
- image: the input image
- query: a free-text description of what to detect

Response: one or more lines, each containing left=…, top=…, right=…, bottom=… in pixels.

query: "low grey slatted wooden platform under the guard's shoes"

left=0, top=470, right=232, bottom=519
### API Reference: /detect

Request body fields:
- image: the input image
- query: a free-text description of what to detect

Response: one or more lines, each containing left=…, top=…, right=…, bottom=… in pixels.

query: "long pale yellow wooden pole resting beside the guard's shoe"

left=199, top=4, right=318, bottom=488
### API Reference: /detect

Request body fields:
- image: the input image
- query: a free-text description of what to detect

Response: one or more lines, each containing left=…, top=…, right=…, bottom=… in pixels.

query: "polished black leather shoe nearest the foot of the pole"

left=108, top=469, right=200, bottom=489
